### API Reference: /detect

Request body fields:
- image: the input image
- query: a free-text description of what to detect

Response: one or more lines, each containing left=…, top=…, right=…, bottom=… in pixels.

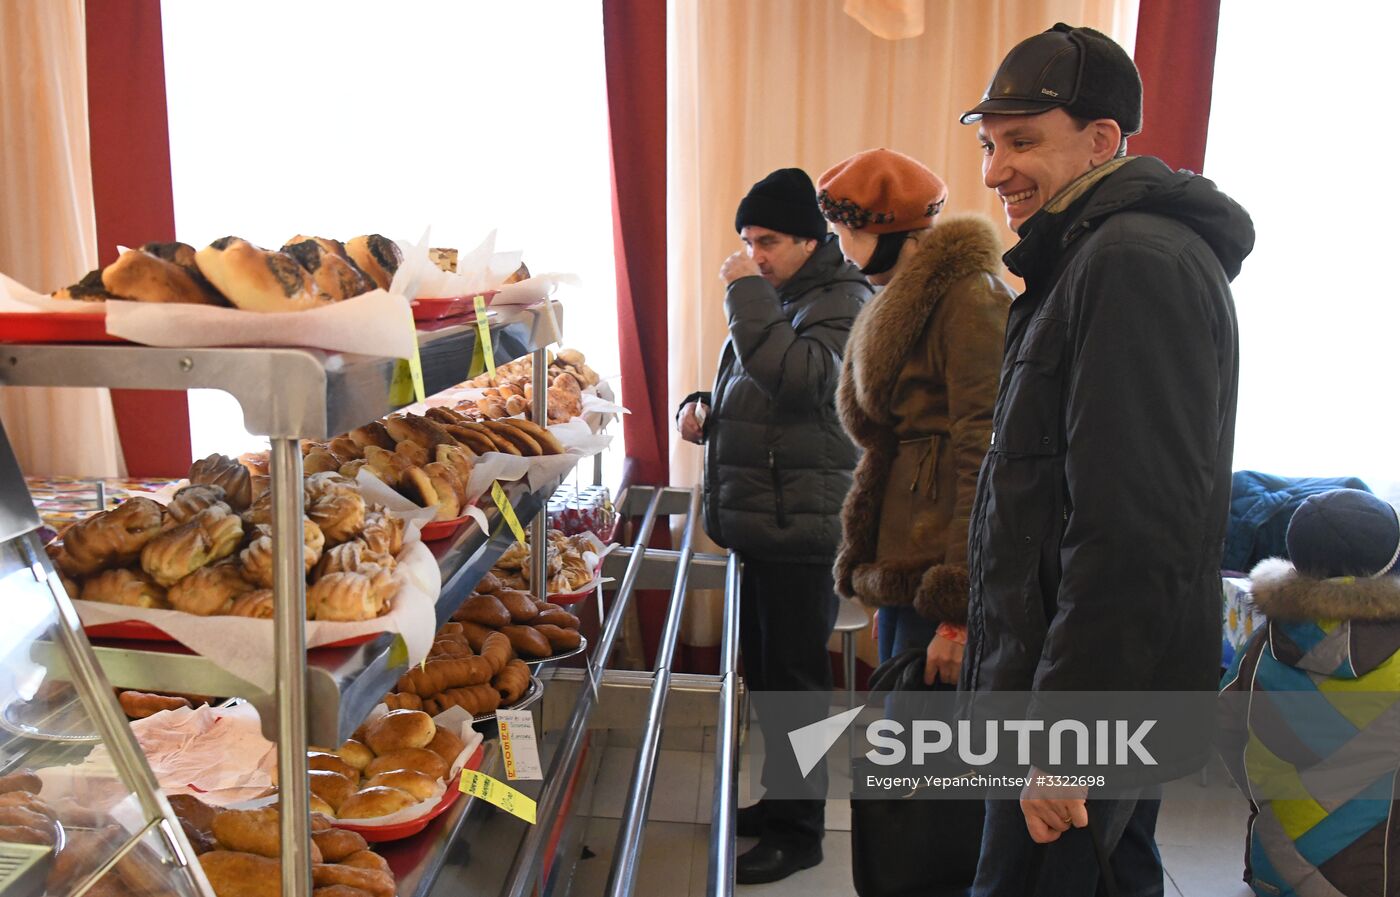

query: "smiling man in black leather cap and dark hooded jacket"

left=960, top=24, right=1254, bottom=897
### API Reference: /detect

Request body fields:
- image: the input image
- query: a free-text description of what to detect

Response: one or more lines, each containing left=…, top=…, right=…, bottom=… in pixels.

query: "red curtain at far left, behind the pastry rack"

left=87, top=0, right=190, bottom=477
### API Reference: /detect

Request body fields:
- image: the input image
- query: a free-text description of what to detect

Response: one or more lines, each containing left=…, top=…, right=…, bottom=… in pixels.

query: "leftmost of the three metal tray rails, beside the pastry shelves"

left=505, top=488, right=664, bottom=897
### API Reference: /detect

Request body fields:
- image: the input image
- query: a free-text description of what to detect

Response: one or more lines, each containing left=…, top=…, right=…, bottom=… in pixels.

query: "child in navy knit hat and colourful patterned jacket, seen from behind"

left=1217, top=488, right=1400, bottom=897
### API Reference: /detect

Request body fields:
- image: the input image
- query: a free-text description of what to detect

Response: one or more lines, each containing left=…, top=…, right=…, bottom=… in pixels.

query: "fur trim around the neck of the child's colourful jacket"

left=1249, top=557, right=1400, bottom=620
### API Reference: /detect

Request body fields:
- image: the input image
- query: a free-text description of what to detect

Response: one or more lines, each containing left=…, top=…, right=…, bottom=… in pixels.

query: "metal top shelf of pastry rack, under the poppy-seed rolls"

left=0, top=302, right=563, bottom=439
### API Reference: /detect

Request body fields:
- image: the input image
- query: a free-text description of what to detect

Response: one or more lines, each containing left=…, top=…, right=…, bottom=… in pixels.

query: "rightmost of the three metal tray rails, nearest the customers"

left=707, top=554, right=743, bottom=894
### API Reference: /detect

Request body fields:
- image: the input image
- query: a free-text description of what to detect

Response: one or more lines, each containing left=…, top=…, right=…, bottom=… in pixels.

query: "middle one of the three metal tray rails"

left=608, top=488, right=700, bottom=897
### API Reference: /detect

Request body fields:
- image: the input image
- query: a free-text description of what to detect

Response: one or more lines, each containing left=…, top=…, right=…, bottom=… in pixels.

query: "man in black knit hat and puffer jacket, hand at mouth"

left=676, top=168, right=871, bottom=884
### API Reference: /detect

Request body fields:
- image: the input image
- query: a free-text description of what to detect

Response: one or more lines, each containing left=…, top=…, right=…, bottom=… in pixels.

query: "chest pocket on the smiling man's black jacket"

left=991, top=318, right=1067, bottom=456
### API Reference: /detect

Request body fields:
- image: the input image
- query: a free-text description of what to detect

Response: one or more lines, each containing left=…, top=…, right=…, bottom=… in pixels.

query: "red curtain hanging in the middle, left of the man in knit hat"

left=603, top=0, right=671, bottom=486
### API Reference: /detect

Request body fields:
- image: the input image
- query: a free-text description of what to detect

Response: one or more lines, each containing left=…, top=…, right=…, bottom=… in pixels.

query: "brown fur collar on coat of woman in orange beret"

left=847, top=216, right=1001, bottom=424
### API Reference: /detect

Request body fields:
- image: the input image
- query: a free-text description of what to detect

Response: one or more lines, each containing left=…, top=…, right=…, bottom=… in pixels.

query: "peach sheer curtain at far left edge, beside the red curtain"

left=0, top=0, right=122, bottom=477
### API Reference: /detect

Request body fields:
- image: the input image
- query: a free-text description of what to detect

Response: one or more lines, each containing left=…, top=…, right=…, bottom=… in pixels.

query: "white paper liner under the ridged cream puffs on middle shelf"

left=73, top=542, right=442, bottom=693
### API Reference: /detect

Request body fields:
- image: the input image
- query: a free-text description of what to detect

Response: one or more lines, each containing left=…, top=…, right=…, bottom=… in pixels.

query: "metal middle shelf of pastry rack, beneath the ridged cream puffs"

left=27, top=480, right=559, bottom=746
